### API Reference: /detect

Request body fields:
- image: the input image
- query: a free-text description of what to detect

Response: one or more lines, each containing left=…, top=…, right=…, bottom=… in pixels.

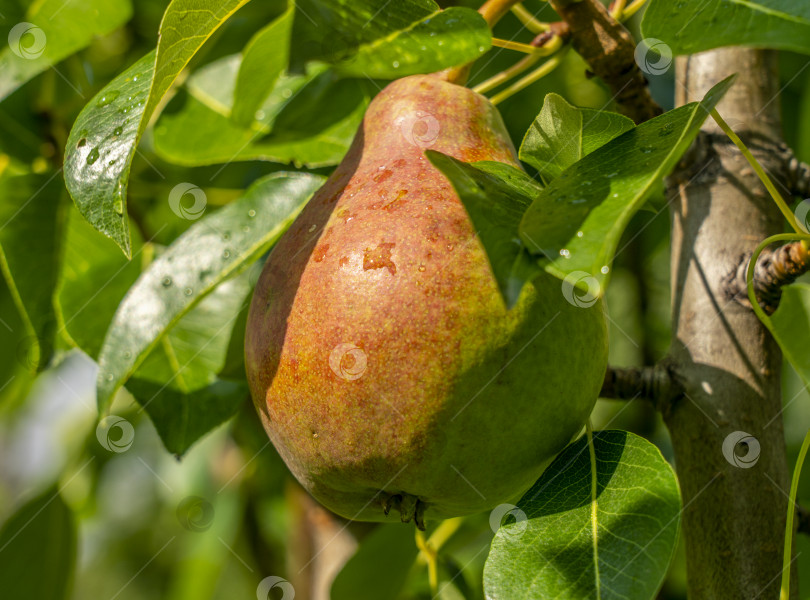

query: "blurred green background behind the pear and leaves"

left=0, top=0, right=810, bottom=600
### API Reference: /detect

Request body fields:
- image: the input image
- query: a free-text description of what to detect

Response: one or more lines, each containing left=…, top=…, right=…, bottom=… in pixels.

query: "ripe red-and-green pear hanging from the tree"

left=245, top=76, right=607, bottom=521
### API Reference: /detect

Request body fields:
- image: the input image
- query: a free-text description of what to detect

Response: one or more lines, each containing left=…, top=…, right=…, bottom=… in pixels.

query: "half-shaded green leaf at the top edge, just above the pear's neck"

left=291, top=0, right=491, bottom=79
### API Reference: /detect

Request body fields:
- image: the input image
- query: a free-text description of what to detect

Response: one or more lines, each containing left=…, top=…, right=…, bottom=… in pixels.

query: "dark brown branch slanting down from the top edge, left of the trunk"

left=549, top=0, right=662, bottom=123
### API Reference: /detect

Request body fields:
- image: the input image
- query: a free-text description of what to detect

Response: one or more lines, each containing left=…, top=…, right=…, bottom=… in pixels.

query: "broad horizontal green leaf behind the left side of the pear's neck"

left=154, top=57, right=371, bottom=168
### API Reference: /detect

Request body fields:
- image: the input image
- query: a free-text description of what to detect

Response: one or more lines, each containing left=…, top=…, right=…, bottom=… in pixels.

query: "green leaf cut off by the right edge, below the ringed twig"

left=770, top=283, right=810, bottom=385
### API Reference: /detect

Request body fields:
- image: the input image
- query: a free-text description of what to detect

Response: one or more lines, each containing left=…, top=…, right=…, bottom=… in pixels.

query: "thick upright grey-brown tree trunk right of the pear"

left=665, top=48, right=796, bottom=600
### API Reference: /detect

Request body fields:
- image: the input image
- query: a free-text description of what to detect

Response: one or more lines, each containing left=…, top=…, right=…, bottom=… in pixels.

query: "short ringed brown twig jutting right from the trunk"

left=725, top=242, right=810, bottom=315
